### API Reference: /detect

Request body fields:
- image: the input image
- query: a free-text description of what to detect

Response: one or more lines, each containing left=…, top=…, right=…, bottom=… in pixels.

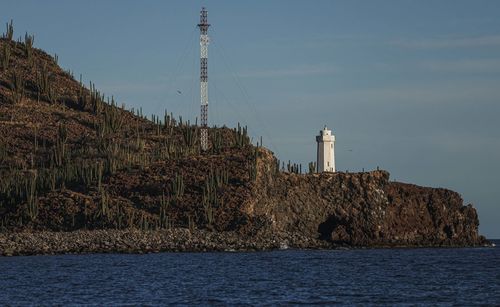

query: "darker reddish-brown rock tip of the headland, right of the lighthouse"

left=384, top=182, right=485, bottom=245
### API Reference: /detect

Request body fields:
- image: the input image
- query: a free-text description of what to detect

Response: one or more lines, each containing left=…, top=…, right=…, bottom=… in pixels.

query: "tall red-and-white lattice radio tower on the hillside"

left=198, top=7, right=210, bottom=151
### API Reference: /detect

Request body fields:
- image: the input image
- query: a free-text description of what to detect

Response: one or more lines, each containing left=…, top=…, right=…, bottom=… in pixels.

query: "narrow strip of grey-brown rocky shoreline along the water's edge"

left=0, top=228, right=490, bottom=256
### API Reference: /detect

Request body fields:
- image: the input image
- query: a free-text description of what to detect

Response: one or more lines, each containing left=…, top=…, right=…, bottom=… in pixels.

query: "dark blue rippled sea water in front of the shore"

left=0, top=244, right=500, bottom=306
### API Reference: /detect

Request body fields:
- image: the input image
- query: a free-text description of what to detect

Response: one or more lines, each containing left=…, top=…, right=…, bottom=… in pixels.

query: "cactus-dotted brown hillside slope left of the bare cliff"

left=0, top=39, right=255, bottom=231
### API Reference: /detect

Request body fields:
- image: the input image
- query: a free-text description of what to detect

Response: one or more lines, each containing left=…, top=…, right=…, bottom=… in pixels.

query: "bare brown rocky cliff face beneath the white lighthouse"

left=248, top=152, right=485, bottom=246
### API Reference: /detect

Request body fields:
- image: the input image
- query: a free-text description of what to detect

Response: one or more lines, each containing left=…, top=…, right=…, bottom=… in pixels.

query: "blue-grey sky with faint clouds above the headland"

left=0, top=0, right=500, bottom=238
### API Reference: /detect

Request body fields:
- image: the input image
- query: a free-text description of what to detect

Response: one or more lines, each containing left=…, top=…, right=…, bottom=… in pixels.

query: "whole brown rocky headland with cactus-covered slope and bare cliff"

left=0, top=28, right=485, bottom=254
